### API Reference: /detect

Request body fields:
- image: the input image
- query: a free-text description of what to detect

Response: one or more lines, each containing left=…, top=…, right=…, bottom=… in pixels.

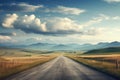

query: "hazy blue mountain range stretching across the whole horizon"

left=0, top=41, right=120, bottom=51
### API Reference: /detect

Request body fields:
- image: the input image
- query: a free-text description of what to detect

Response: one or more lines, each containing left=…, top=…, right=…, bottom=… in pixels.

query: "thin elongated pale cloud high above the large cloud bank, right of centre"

left=46, top=6, right=85, bottom=15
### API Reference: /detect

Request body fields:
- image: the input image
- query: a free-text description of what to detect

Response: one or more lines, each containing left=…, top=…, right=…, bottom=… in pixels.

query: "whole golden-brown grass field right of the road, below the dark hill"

left=67, top=54, right=120, bottom=79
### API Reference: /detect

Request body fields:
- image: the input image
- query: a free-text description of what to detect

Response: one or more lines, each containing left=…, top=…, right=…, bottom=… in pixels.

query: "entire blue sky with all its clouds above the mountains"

left=0, top=0, right=120, bottom=45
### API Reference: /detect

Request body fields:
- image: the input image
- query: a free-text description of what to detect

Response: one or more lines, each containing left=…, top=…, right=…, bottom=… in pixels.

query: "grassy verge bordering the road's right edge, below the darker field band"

left=66, top=55, right=120, bottom=79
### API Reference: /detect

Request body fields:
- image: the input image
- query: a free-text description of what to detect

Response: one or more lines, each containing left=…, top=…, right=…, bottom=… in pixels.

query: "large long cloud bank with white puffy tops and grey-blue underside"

left=2, top=13, right=81, bottom=35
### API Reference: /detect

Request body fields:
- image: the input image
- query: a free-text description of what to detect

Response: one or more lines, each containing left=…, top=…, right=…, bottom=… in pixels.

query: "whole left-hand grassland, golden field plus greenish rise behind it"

left=0, top=49, right=58, bottom=79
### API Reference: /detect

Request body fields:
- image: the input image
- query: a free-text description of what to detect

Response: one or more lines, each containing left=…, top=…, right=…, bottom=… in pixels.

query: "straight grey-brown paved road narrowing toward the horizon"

left=6, top=56, right=116, bottom=80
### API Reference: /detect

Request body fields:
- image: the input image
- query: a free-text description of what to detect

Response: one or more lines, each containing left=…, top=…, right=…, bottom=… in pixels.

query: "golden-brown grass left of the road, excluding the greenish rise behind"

left=0, top=54, right=58, bottom=80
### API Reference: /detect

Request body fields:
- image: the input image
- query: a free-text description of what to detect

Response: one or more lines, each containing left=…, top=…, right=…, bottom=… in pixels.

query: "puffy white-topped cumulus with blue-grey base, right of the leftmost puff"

left=15, top=14, right=47, bottom=33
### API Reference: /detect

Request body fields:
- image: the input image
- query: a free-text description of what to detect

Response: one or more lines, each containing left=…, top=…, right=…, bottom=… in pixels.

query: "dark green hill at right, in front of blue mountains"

left=84, top=47, right=120, bottom=54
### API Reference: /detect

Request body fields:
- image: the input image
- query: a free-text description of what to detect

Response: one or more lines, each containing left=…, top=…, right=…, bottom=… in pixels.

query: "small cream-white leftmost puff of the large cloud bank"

left=2, top=14, right=18, bottom=28
